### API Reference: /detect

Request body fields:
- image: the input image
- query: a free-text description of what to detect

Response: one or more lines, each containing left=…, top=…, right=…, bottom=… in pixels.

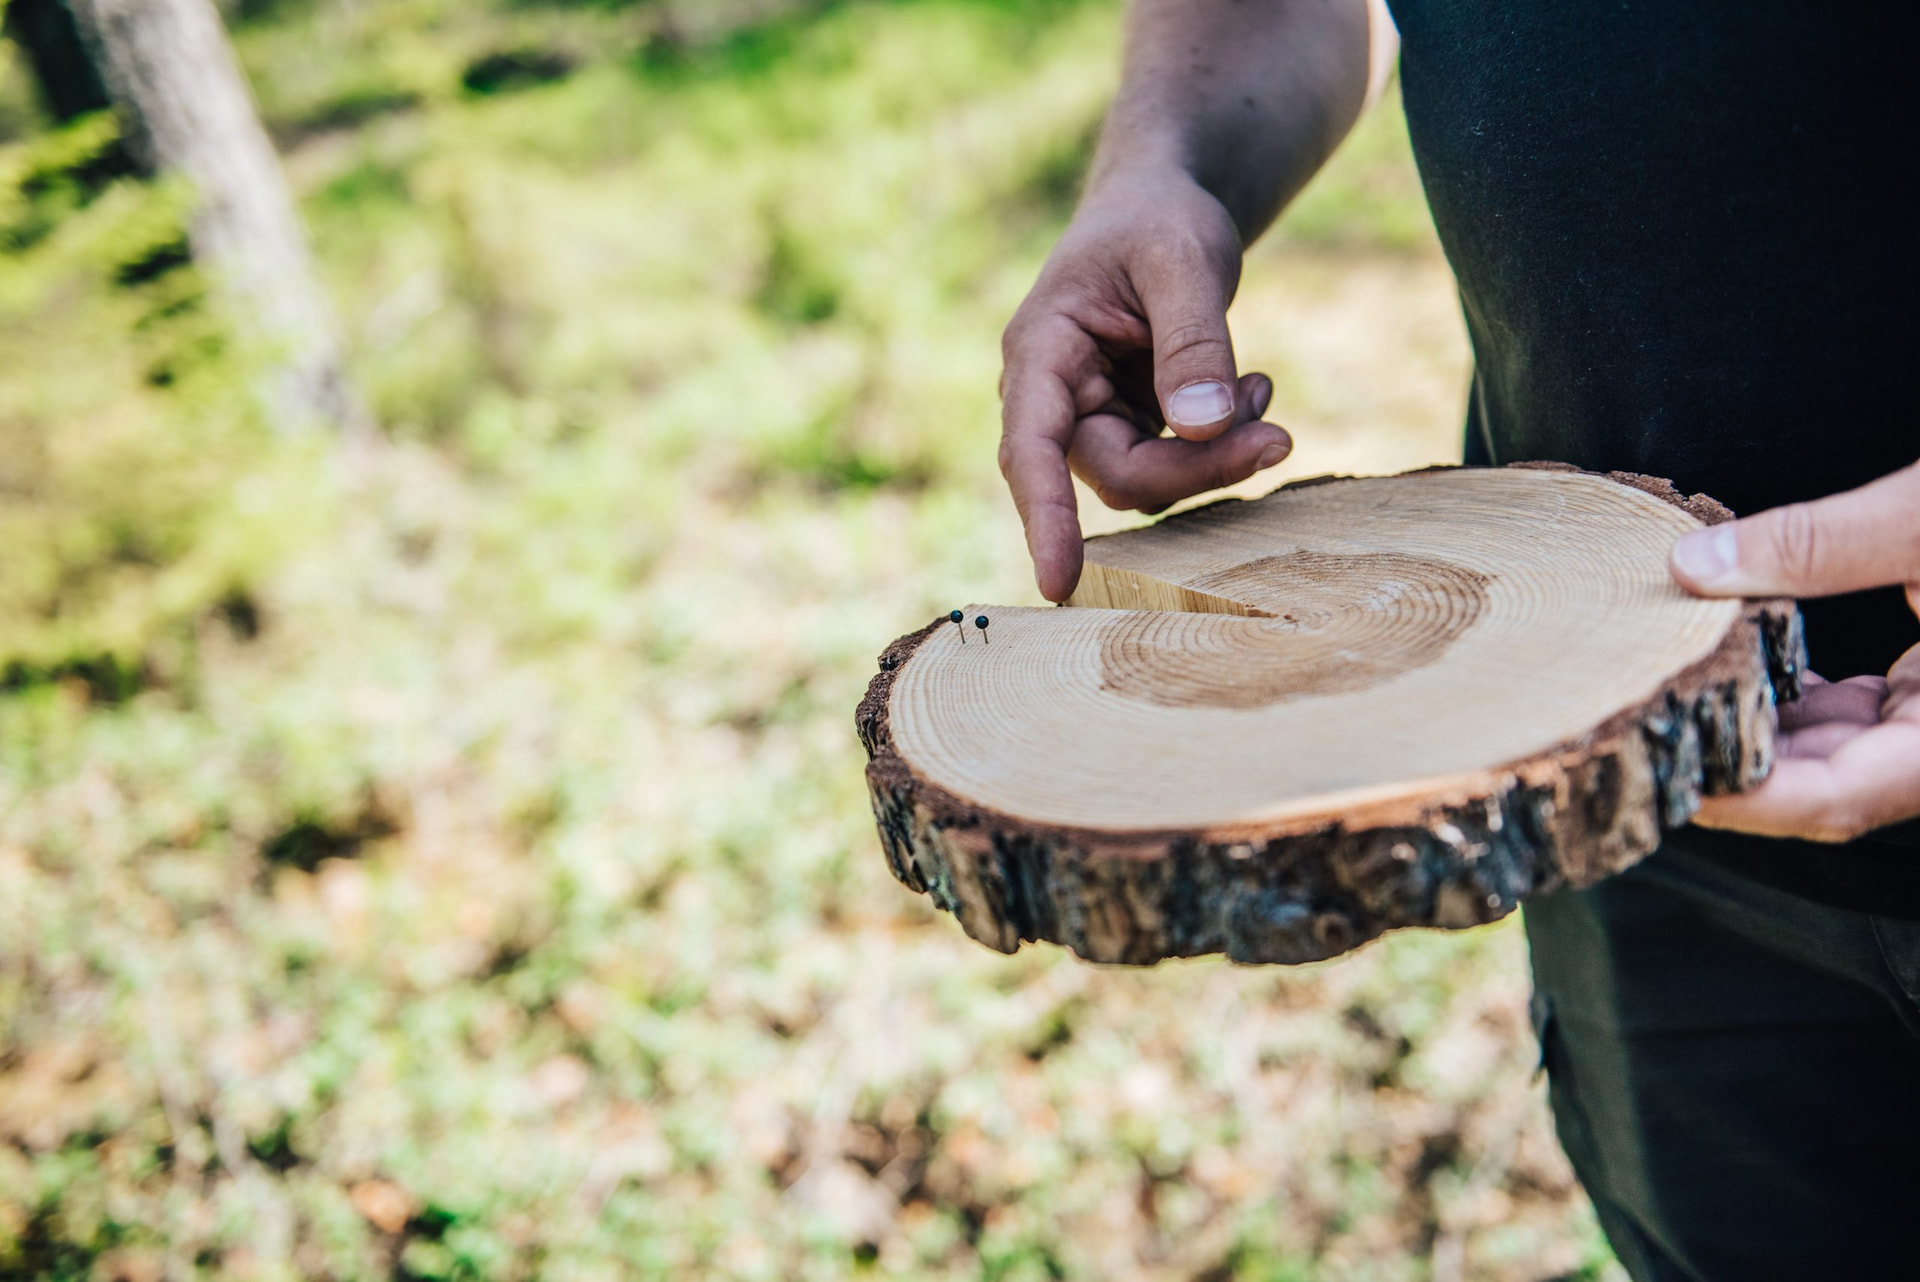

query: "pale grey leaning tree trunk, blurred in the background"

left=67, top=0, right=369, bottom=434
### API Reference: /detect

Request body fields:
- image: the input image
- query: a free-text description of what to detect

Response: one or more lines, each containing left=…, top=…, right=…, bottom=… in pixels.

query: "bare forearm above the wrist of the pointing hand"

left=1089, top=0, right=1369, bottom=242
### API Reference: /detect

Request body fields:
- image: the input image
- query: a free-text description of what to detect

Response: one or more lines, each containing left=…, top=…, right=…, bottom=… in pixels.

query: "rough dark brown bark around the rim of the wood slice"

left=858, top=474, right=1805, bottom=965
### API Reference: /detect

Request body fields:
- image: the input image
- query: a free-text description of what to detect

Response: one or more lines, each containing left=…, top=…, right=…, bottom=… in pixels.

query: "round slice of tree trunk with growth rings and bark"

left=858, top=464, right=1805, bottom=963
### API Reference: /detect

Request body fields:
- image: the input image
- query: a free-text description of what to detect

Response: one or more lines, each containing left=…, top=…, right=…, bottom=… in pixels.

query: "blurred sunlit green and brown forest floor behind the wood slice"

left=0, top=0, right=1617, bottom=1282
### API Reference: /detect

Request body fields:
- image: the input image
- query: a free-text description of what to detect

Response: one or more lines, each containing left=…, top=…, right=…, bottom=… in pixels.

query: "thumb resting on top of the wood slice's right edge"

left=1670, top=466, right=1920, bottom=597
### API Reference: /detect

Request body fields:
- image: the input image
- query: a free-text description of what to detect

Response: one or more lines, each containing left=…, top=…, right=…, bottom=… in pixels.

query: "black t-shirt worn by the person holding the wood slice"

left=1392, top=0, right=1920, bottom=917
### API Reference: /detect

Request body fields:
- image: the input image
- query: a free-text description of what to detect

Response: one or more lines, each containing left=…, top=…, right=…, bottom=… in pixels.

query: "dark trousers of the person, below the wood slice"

left=1526, top=831, right=1920, bottom=1282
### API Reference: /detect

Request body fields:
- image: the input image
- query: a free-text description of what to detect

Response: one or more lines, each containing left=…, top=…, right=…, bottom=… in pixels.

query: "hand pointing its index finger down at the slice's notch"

left=1000, top=171, right=1292, bottom=601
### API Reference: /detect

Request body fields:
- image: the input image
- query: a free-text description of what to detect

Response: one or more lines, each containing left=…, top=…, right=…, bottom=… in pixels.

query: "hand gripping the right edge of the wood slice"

left=1672, top=464, right=1920, bottom=841
